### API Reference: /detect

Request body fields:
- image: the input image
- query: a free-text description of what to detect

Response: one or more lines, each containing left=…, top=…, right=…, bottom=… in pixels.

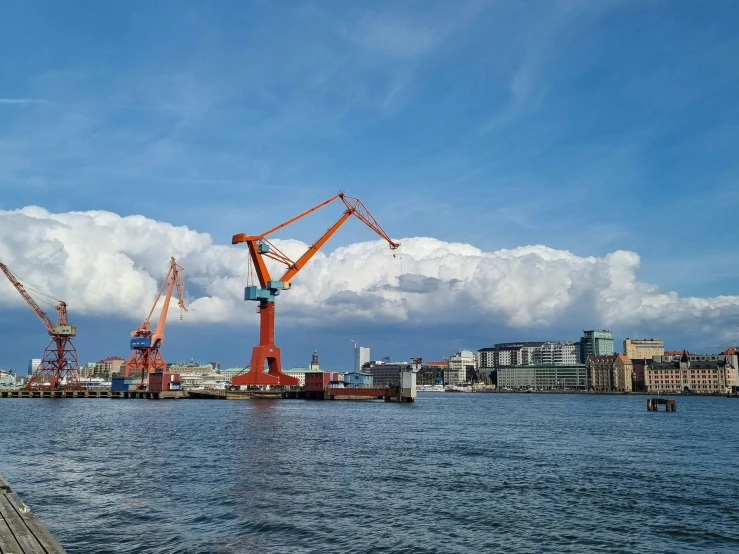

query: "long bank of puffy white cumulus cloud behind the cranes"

left=0, top=207, right=739, bottom=334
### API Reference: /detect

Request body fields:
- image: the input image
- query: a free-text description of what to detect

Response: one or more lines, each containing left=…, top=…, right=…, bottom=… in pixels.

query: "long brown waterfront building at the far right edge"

left=644, top=352, right=737, bottom=394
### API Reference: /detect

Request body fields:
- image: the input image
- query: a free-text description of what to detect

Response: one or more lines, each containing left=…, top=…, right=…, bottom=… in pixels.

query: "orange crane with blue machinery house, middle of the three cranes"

left=124, top=258, right=187, bottom=385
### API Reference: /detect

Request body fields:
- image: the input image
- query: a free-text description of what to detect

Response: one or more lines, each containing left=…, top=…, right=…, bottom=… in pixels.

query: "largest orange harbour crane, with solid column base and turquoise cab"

left=231, top=192, right=400, bottom=386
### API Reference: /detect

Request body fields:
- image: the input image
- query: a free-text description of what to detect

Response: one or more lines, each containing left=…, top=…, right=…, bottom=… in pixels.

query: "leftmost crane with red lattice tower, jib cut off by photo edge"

left=0, top=263, right=80, bottom=389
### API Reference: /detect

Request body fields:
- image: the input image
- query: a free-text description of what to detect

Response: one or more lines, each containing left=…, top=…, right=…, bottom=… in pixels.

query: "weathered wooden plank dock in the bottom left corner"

left=0, top=477, right=65, bottom=554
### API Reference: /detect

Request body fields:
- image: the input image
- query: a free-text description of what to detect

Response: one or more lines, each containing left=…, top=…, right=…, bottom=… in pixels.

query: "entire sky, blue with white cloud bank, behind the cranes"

left=0, top=0, right=739, bottom=369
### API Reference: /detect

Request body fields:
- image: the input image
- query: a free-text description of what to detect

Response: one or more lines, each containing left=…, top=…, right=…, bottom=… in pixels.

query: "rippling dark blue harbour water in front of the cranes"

left=0, top=393, right=739, bottom=554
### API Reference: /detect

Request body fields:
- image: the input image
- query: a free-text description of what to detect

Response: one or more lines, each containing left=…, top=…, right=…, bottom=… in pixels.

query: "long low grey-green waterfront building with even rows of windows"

left=498, top=364, right=588, bottom=390
